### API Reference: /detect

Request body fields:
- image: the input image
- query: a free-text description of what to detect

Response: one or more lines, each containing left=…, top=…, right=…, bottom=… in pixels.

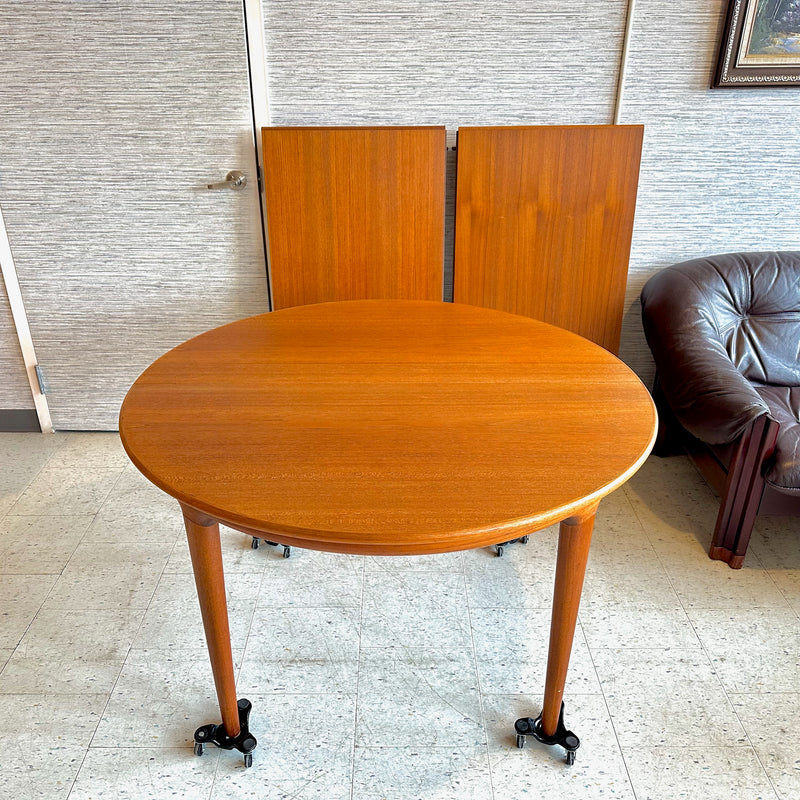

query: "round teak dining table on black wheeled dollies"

left=120, top=300, right=657, bottom=766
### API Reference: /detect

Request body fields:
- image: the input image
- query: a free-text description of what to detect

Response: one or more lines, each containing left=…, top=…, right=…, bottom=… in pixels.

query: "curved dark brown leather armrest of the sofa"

left=641, top=268, right=769, bottom=444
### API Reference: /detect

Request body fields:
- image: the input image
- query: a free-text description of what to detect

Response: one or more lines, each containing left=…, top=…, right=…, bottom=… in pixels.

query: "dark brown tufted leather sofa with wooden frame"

left=641, top=251, right=800, bottom=568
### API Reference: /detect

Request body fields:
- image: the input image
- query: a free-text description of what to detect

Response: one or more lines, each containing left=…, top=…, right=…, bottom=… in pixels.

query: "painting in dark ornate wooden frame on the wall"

left=713, top=0, right=800, bottom=88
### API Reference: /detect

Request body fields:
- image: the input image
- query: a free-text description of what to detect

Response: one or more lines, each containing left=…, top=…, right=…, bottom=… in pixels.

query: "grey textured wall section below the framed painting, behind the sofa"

left=620, top=0, right=800, bottom=381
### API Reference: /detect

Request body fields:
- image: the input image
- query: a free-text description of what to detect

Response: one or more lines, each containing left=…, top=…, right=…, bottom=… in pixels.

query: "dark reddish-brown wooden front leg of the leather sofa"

left=708, top=415, right=780, bottom=569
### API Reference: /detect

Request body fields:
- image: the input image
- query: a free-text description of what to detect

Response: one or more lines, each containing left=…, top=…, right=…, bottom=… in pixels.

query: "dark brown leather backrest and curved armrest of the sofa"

left=641, top=251, right=800, bottom=445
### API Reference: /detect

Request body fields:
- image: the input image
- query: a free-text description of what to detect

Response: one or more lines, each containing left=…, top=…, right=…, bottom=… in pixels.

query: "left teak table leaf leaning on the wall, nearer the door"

left=262, top=127, right=446, bottom=309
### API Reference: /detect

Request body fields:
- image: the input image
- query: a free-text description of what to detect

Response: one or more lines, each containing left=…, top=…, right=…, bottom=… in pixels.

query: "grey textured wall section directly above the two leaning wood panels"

left=264, top=0, right=626, bottom=130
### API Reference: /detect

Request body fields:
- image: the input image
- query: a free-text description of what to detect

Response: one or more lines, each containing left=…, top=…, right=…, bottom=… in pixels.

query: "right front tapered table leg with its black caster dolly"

left=514, top=508, right=597, bottom=764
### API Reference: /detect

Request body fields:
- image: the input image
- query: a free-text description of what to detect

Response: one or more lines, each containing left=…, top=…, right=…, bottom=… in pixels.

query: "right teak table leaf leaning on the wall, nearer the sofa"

left=454, top=125, right=643, bottom=353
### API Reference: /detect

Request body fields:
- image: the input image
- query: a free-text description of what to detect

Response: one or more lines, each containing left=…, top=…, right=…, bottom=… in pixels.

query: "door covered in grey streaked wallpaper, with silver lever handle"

left=0, top=0, right=268, bottom=430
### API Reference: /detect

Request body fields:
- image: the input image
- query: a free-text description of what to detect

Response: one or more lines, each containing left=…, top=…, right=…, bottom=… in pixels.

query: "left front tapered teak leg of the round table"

left=181, top=506, right=240, bottom=737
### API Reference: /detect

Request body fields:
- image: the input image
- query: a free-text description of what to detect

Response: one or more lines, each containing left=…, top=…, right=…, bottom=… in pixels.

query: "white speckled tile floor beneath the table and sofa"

left=0, top=433, right=800, bottom=800
